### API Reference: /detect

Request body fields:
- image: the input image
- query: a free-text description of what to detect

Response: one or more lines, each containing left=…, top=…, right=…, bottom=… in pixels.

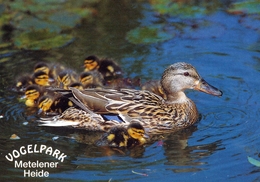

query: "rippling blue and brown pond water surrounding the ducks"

left=0, top=1, right=260, bottom=181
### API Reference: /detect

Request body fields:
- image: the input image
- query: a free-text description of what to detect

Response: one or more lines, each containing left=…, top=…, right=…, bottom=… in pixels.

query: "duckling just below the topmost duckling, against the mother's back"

left=80, top=71, right=105, bottom=88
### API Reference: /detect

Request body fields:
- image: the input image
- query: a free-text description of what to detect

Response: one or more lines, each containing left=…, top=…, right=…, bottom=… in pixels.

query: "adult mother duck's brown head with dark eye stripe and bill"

left=161, top=62, right=222, bottom=102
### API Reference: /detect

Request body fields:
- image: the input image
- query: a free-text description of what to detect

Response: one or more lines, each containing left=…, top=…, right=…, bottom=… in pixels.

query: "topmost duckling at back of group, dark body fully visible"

left=84, top=55, right=123, bottom=81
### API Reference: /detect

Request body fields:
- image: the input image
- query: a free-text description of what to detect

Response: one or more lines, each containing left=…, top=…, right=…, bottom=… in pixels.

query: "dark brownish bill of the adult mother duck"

left=194, top=79, right=223, bottom=96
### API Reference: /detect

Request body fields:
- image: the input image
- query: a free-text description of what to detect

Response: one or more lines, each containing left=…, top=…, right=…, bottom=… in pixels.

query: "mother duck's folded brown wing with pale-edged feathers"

left=70, top=88, right=164, bottom=117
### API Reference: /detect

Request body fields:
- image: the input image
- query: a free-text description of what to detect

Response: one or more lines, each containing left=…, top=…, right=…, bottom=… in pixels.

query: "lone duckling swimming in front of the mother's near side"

left=96, top=122, right=146, bottom=148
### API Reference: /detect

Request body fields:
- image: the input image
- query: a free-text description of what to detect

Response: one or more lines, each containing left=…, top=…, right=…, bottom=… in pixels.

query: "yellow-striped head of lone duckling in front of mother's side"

left=127, top=121, right=146, bottom=145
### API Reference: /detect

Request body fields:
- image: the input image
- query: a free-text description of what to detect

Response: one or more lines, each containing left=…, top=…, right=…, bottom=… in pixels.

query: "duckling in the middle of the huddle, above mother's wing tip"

left=57, top=70, right=78, bottom=90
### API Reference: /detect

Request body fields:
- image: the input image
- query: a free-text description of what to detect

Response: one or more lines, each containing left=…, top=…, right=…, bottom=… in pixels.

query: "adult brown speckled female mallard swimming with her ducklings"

left=38, top=62, right=222, bottom=134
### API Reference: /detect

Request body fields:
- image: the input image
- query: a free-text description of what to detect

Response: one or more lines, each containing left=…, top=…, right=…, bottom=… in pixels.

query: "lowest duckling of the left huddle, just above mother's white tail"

left=38, top=94, right=74, bottom=114
